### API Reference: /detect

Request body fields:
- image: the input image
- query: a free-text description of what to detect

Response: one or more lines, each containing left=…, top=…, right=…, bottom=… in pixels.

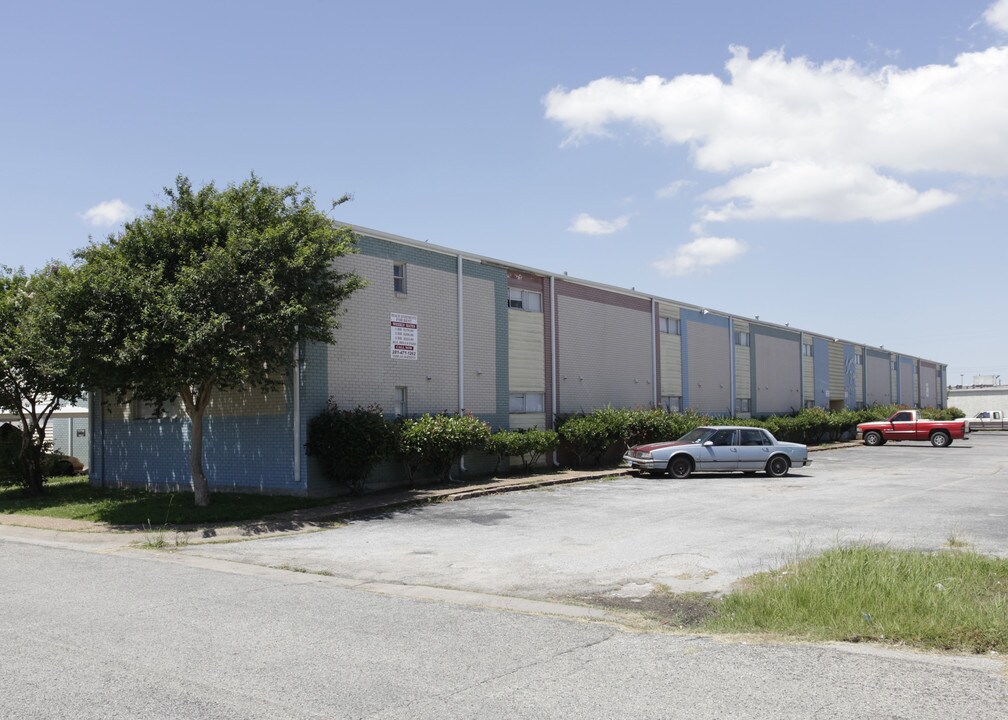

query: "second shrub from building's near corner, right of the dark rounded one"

left=397, top=412, right=490, bottom=485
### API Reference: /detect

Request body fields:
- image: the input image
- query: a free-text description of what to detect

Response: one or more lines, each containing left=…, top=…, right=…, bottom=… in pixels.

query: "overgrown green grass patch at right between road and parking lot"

left=703, top=545, right=1008, bottom=653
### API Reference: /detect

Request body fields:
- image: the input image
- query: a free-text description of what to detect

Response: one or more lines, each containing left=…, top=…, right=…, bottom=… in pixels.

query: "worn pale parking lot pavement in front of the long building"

left=181, top=434, right=1008, bottom=598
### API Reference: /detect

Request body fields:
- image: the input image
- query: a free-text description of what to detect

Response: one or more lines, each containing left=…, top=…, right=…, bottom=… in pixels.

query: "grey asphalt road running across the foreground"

left=0, top=537, right=1008, bottom=720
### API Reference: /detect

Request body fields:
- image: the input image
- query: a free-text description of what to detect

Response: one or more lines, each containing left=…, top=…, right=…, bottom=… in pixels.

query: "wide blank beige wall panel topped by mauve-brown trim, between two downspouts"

left=556, top=295, right=654, bottom=412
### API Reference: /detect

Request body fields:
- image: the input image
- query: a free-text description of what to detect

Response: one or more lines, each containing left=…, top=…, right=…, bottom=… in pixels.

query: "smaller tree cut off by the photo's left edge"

left=0, top=263, right=84, bottom=495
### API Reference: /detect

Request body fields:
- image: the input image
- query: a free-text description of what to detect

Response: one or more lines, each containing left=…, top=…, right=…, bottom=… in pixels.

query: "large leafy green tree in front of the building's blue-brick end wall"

left=70, top=175, right=362, bottom=505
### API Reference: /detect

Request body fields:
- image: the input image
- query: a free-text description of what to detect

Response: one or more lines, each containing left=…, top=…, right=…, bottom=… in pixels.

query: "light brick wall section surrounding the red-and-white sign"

left=326, top=255, right=461, bottom=414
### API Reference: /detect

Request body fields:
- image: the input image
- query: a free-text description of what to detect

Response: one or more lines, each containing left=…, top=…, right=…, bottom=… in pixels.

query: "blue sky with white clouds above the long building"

left=0, top=0, right=1008, bottom=383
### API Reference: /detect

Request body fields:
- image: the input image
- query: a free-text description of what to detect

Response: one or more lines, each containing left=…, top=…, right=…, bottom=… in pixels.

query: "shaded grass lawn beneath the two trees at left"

left=0, top=477, right=333, bottom=527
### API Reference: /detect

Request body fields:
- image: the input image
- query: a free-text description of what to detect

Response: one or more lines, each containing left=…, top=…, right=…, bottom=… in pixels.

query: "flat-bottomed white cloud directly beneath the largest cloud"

left=703, top=161, right=957, bottom=222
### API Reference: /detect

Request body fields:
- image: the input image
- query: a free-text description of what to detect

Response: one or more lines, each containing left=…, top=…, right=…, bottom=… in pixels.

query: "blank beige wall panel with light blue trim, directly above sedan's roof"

left=686, top=321, right=735, bottom=414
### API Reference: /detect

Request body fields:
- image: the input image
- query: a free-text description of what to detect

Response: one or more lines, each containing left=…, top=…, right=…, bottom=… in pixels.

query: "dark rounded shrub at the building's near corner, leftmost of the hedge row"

left=304, top=401, right=395, bottom=493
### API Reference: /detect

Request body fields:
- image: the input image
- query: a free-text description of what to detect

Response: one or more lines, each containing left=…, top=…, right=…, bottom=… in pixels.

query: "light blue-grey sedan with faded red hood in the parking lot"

left=623, top=426, right=812, bottom=479
